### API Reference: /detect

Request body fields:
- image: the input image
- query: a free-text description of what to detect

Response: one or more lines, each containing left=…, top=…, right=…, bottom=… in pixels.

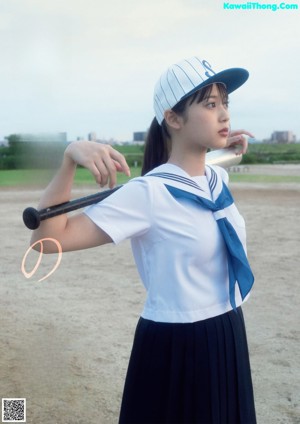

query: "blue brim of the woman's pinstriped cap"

left=181, top=68, right=249, bottom=100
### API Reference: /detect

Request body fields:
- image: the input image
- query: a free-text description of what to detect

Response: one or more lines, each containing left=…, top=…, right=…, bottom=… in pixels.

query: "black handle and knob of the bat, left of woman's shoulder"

left=23, top=185, right=122, bottom=230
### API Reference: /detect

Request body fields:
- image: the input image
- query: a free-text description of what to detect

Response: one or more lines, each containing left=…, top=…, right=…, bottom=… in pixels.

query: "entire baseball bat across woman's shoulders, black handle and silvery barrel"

left=23, top=147, right=242, bottom=230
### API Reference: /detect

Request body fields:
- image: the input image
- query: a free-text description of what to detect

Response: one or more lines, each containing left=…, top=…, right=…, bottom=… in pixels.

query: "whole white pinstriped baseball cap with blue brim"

left=154, top=56, right=249, bottom=124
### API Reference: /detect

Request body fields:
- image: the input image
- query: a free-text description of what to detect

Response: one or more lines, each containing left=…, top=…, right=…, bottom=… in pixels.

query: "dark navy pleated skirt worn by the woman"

left=119, top=308, right=256, bottom=424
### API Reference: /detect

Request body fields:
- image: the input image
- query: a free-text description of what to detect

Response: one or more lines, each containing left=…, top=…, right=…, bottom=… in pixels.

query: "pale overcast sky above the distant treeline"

left=0, top=0, right=300, bottom=140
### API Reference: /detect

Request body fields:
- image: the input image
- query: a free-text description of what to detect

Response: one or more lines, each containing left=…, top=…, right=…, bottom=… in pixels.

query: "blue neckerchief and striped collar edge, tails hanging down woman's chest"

left=148, top=168, right=254, bottom=309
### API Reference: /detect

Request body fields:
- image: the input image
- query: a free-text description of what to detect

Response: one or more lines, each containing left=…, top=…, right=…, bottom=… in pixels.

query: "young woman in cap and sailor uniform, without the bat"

left=32, top=57, right=256, bottom=424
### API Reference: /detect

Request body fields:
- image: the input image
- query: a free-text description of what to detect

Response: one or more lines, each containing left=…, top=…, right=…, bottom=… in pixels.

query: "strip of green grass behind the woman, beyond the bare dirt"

left=0, top=167, right=300, bottom=188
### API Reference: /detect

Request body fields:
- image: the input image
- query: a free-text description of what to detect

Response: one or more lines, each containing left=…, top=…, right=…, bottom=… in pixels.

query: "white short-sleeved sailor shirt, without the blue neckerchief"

left=85, top=164, right=248, bottom=323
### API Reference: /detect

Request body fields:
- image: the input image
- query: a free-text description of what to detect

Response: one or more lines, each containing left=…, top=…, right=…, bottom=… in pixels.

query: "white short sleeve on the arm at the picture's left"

left=84, top=178, right=153, bottom=244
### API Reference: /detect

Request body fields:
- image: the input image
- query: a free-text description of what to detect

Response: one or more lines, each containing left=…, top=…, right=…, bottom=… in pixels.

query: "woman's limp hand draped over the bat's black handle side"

left=65, top=141, right=130, bottom=188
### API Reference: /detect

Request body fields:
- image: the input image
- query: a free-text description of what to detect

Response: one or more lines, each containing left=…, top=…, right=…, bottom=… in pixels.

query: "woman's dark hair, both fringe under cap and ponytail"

left=142, top=83, right=228, bottom=175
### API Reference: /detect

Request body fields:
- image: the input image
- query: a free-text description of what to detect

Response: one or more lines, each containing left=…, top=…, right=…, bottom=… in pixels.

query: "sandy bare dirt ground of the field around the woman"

left=0, top=166, right=300, bottom=424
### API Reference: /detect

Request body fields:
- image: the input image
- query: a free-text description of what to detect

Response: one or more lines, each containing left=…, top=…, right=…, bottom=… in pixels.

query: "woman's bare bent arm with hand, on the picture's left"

left=31, top=141, right=130, bottom=253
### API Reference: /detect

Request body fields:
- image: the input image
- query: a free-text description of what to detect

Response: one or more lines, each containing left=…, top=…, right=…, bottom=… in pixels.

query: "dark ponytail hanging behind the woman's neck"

left=142, top=118, right=169, bottom=175
